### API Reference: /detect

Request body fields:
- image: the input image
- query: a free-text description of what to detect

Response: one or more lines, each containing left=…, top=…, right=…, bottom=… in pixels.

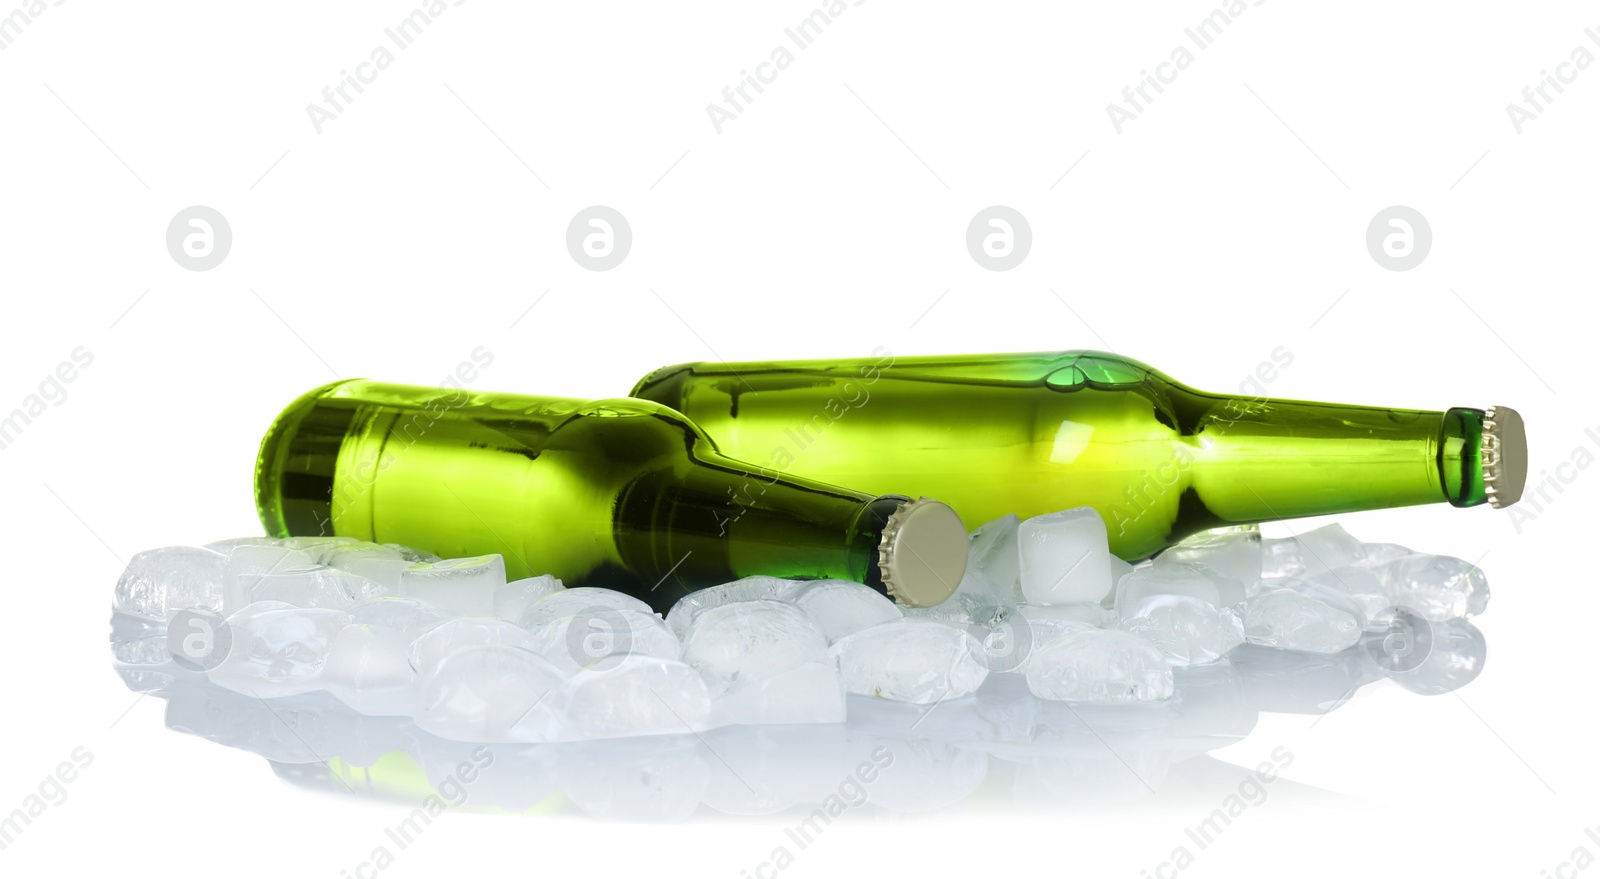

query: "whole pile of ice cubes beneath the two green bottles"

left=112, top=508, right=1488, bottom=741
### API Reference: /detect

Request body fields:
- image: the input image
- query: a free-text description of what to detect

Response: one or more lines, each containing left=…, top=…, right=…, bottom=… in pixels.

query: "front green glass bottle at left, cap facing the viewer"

left=256, top=379, right=966, bottom=610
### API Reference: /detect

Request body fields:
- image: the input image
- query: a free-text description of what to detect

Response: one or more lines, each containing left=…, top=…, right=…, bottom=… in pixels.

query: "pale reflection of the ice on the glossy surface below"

left=114, top=621, right=1486, bottom=819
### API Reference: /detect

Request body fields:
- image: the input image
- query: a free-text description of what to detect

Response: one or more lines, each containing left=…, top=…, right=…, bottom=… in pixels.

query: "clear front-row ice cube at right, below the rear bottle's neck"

left=1245, top=578, right=1365, bottom=653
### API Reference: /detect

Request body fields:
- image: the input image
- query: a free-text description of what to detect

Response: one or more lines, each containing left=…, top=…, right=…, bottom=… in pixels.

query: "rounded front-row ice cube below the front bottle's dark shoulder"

left=563, top=650, right=713, bottom=738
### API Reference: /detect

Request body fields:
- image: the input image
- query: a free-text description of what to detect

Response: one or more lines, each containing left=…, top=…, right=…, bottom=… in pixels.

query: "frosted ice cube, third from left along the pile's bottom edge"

left=416, top=645, right=565, bottom=741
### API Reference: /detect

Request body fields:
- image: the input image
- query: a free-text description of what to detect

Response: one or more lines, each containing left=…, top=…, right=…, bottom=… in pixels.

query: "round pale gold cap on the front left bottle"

left=878, top=498, right=966, bottom=607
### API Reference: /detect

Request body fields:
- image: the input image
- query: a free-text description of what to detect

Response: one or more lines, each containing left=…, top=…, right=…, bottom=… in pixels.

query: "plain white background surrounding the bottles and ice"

left=0, top=0, right=1600, bottom=877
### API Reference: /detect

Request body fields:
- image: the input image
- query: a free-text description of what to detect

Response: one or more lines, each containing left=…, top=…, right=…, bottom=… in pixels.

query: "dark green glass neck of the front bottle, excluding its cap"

left=616, top=444, right=909, bottom=610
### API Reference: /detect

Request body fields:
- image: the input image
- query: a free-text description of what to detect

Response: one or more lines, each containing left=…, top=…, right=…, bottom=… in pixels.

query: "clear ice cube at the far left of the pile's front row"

left=206, top=602, right=352, bottom=698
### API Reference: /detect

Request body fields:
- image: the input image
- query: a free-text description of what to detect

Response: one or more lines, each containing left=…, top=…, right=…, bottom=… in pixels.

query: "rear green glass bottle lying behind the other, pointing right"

left=632, top=351, right=1526, bottom=560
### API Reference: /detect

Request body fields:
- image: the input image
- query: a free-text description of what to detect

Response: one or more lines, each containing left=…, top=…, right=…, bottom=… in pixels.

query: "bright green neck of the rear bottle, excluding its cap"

left=1176, top=392, right=1486, bottom=524
